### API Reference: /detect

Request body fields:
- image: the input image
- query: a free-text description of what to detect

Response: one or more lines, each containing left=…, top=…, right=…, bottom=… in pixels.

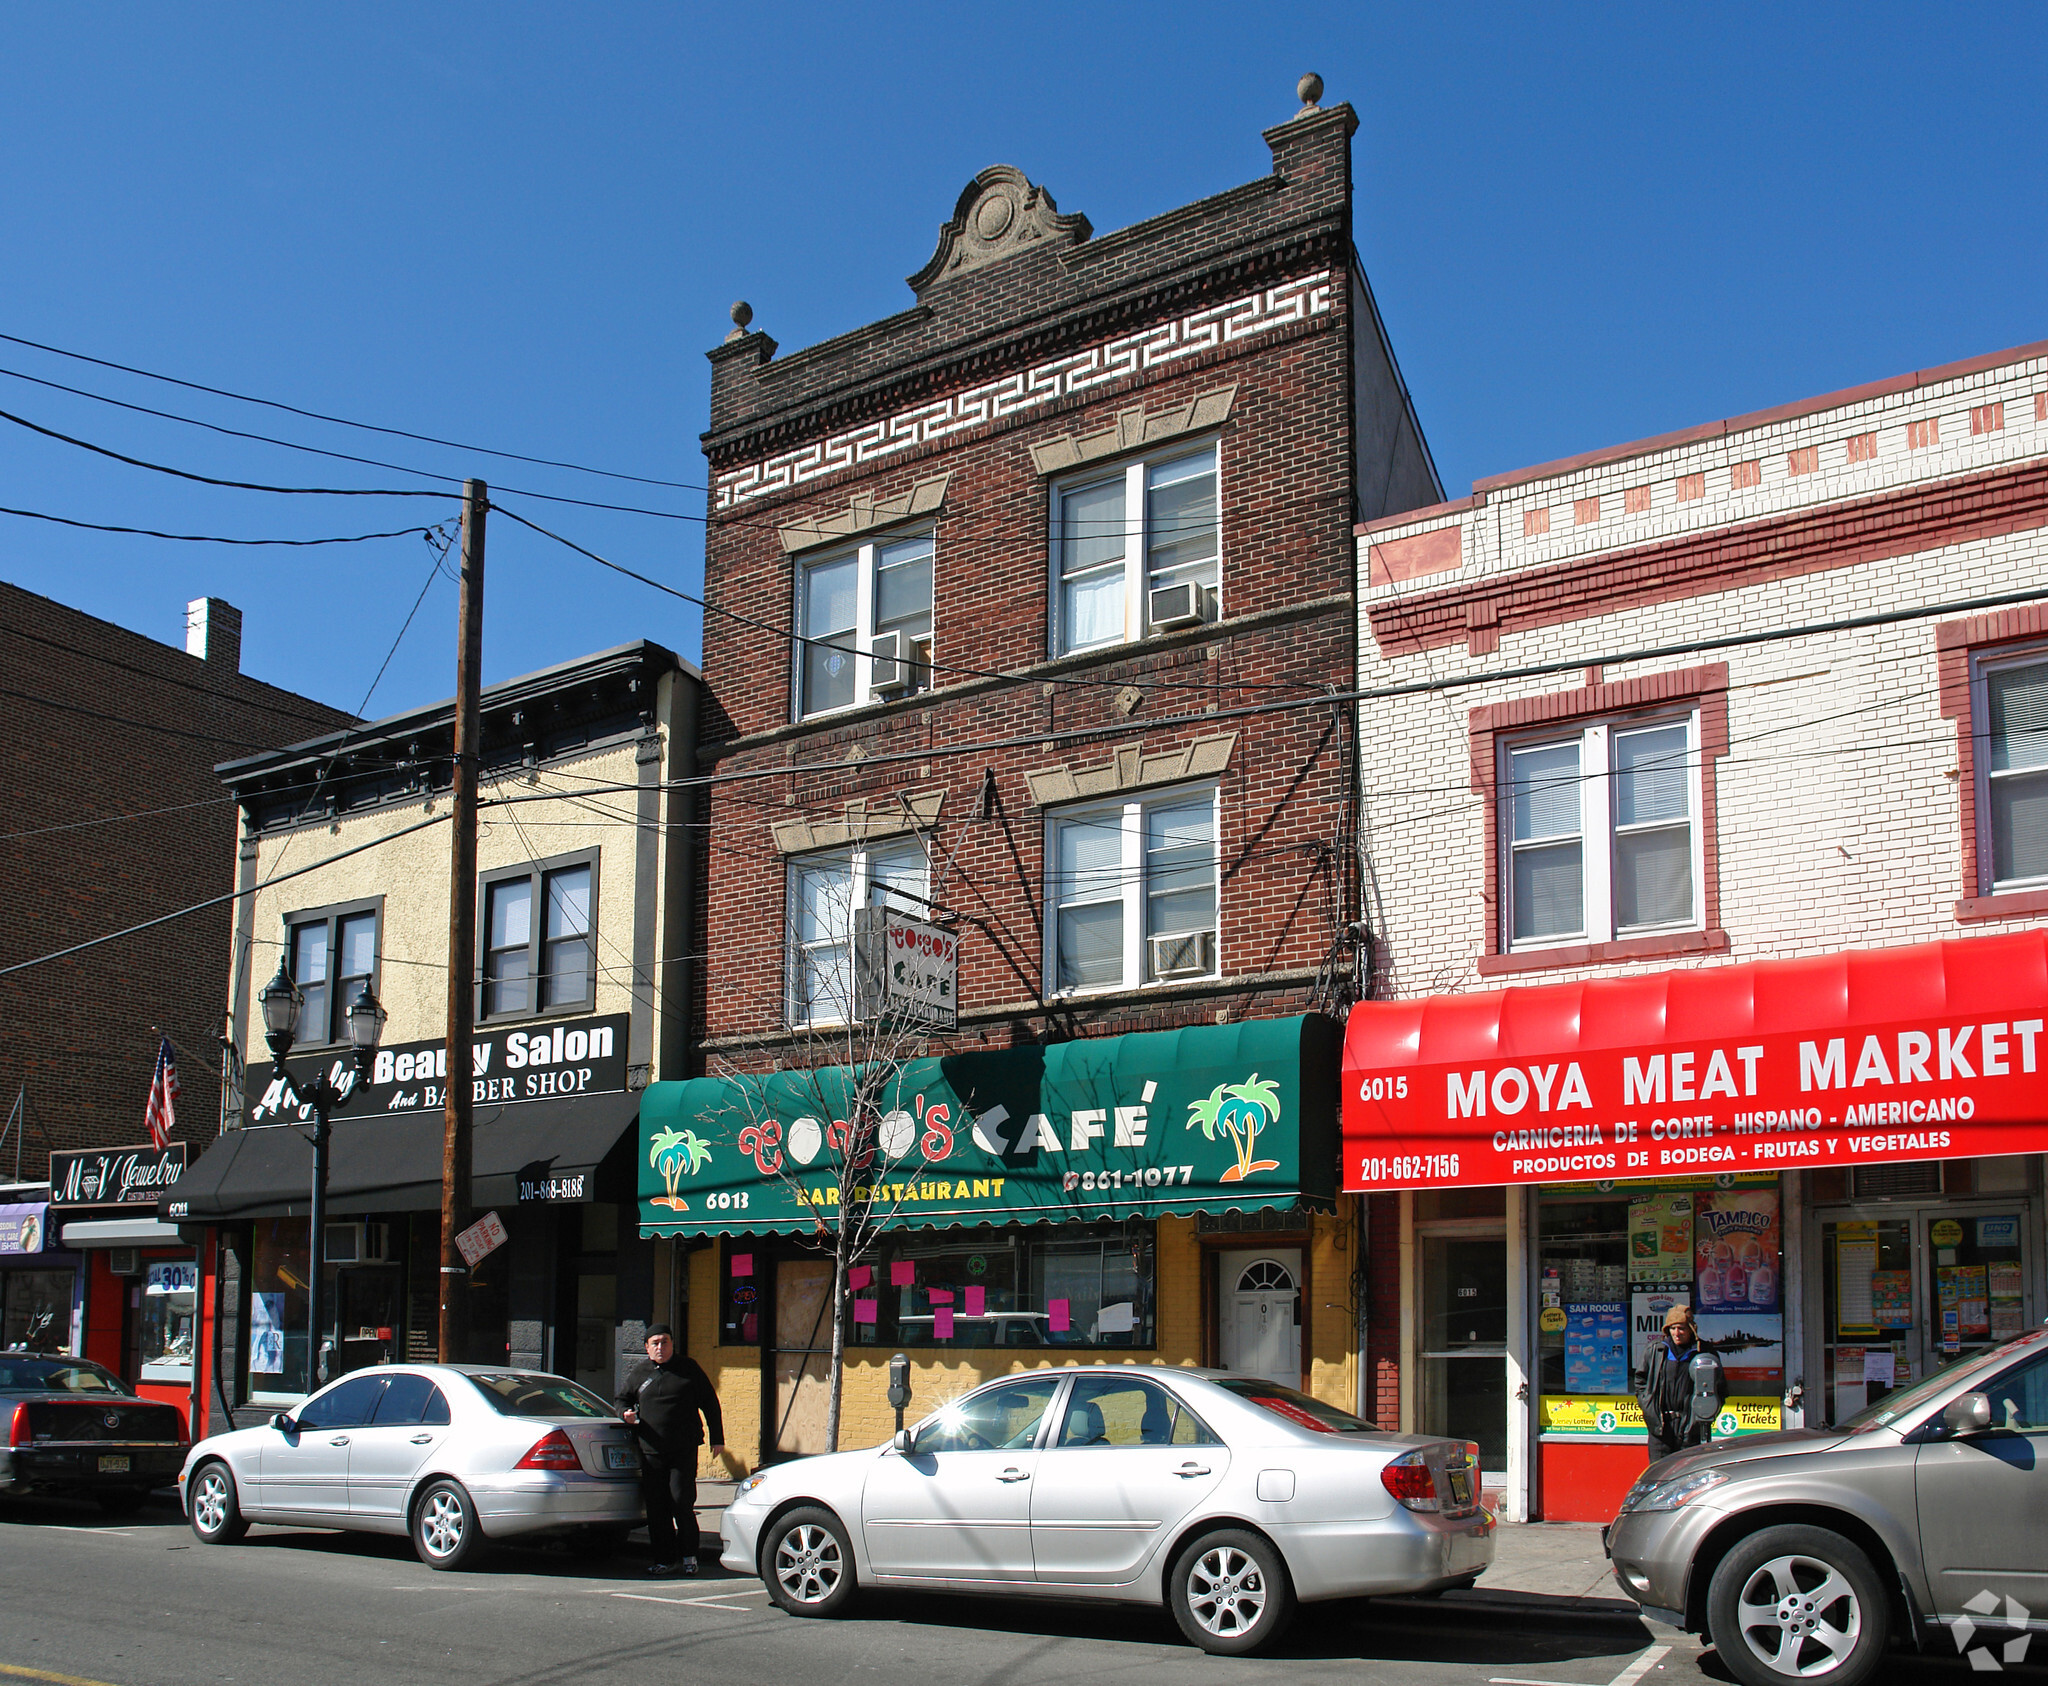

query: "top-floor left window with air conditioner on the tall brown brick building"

left=797, top=533, right=932, bottom=719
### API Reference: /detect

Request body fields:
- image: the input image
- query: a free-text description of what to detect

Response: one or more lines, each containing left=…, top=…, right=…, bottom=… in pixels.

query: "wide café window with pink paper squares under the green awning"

left=846, top=1223, right=1157, bottom=1348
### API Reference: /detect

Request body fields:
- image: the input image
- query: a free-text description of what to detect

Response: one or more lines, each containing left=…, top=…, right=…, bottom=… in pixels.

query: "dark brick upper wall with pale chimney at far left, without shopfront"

left=0, top=584, right=350, bottom=1176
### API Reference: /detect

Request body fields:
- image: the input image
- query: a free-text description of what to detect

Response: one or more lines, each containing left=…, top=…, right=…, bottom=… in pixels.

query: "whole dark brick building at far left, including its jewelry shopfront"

left=0, top=584, right=350, bottom=1403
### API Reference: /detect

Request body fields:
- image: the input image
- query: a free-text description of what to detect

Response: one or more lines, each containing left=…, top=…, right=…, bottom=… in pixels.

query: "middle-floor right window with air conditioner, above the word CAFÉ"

left=1047, top=789, right=1217, bottom=994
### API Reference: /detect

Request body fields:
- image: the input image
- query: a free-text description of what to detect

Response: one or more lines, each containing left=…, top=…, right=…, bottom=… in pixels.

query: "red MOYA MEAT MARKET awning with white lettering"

left=1343, top=930, right=2048, bottom=1192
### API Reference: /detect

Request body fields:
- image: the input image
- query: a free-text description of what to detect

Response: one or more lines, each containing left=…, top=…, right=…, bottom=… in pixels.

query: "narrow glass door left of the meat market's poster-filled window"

left=1415, top=1227, right=1507, bottom=1487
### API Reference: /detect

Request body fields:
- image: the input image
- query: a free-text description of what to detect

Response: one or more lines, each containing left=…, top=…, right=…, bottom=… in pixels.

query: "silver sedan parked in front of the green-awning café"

left=721, top=1366, right=1495, bottom=1655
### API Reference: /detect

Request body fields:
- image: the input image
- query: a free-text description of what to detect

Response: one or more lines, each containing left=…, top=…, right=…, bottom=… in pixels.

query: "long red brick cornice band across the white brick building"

left=1370, top=459, right=2048, bottom=656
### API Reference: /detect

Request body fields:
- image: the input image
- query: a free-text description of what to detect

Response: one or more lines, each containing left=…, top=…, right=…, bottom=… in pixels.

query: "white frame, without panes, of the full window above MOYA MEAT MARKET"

left=1493, top=709, right=1706, bottom=955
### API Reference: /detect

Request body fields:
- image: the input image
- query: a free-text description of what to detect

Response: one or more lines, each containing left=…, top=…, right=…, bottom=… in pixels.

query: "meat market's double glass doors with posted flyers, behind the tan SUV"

left=1808, top=1196, right=2040, bottom=1422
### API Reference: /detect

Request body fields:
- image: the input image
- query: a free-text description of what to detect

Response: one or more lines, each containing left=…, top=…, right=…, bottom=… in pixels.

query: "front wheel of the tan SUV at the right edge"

left=1706, top=1524, right=1890, bottom=1686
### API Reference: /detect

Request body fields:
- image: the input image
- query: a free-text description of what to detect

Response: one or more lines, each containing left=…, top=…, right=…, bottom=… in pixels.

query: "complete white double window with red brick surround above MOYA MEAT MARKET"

left=1501, top=715, right=1704, bottom=949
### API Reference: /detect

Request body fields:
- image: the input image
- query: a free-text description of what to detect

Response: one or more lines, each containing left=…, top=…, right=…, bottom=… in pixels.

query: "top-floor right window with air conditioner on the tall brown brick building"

left=1053, top=447, right=1223, bottom=656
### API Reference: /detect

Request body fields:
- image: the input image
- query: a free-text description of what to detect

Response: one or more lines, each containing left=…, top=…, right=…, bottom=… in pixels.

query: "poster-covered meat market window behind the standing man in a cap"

left=1536, top=1178, right=1784, bottom=1432
